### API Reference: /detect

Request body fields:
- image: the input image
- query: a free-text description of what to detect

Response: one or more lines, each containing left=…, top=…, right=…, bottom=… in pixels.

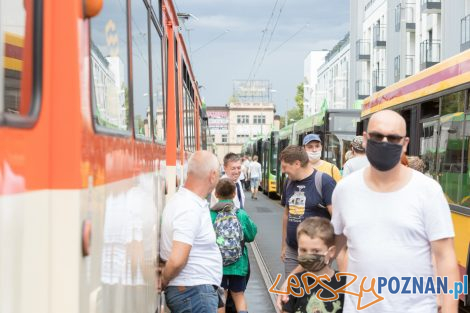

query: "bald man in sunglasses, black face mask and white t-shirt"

left=332, top=110, right=458, bottom=313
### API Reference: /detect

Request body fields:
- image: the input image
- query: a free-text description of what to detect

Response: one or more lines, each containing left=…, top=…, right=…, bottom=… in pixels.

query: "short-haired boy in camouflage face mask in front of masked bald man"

left=282, top=217, right=346, bottom=313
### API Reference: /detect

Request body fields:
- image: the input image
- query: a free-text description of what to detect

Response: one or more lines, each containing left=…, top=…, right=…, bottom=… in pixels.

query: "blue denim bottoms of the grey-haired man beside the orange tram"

left=165, top=285, right=219, bottom=313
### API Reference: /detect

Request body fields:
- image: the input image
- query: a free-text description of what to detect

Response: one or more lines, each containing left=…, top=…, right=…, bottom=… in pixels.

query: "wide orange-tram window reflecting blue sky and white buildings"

left=90, top=1, right=130, bottom=131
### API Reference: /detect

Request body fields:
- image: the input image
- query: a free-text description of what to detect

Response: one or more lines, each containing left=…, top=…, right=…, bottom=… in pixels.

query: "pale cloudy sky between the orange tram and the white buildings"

left=174, top=0, right=349, bottom=114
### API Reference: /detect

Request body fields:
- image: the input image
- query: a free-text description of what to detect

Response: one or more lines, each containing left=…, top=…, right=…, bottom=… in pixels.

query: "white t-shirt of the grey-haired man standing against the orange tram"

left=160, top=187, right=223, bottom=286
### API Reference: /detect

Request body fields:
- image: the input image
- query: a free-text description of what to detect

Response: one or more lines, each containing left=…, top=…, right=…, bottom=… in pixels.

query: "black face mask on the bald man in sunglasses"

left=366, top=139, right=403, bottom=172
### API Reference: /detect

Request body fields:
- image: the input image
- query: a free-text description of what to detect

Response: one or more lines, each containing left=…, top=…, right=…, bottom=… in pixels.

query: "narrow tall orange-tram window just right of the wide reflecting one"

left=131, top=0, right=152, bottom=139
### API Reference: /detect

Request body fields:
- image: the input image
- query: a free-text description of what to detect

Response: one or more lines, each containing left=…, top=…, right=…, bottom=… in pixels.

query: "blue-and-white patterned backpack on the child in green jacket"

left=214, top=208, right=243, bottom=266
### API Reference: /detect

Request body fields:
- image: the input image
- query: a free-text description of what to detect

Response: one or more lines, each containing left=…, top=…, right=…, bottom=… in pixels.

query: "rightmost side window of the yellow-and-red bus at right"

left=437, top=92, right=465, bottom=203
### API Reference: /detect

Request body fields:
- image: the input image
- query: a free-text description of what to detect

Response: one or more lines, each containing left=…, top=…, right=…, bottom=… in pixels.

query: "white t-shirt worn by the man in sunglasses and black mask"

left=331, top=169, right=454, bottom=313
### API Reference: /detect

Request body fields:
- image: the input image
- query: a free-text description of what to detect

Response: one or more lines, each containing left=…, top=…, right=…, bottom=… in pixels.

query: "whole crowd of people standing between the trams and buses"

left=159, top=110, right=459, bottom=313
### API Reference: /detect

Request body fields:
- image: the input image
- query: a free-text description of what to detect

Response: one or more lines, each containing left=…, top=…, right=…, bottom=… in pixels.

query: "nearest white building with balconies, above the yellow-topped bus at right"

left=349, top=0, right=470, bottom=102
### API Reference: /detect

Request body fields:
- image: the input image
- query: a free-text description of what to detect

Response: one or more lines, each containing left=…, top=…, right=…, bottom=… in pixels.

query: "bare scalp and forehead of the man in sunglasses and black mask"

left=367, top=110, right=406, bottom=136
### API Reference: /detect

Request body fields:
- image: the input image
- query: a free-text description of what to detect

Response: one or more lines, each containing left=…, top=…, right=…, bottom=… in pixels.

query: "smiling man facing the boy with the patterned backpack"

left=211, top=152, right=245, bottom=209
